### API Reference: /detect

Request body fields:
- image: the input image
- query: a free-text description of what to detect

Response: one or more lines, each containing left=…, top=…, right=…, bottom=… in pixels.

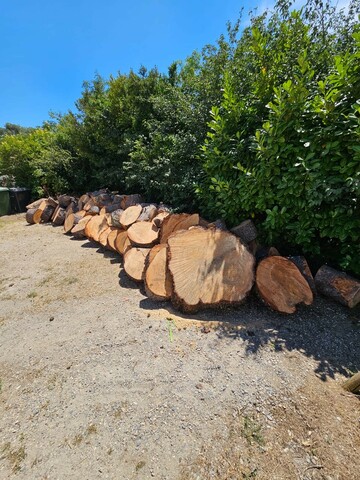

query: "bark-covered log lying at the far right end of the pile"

left=315, top=265, right=360, bottom=308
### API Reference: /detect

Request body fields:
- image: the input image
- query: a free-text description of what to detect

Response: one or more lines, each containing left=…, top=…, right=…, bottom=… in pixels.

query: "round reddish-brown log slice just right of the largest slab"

left=256, top=256, right=313, bottom=313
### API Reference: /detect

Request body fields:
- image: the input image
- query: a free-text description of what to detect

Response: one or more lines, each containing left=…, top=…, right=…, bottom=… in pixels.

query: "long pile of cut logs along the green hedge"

left=26, top=190, right=360, bottom=313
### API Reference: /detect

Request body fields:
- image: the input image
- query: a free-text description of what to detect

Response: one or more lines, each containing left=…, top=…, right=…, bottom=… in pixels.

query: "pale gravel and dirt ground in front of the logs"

left=0, top=216, right=360, bottom=480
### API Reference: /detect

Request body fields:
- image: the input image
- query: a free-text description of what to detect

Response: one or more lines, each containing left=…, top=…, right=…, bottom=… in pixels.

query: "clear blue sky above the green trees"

left=0, top=0, right=272, bottom=126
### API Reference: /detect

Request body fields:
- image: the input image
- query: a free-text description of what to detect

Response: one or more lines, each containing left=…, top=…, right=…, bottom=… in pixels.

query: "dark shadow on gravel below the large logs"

left=140, top=295, right=360, bottom=380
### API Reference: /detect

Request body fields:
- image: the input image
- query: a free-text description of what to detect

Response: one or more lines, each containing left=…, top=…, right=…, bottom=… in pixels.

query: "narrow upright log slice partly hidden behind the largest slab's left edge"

left=145, top=243, right=172, bottom=300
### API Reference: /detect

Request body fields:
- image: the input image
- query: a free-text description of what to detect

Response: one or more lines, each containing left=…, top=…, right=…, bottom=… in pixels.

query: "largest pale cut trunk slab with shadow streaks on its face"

left=168, top=227, right=255, bottom=312
